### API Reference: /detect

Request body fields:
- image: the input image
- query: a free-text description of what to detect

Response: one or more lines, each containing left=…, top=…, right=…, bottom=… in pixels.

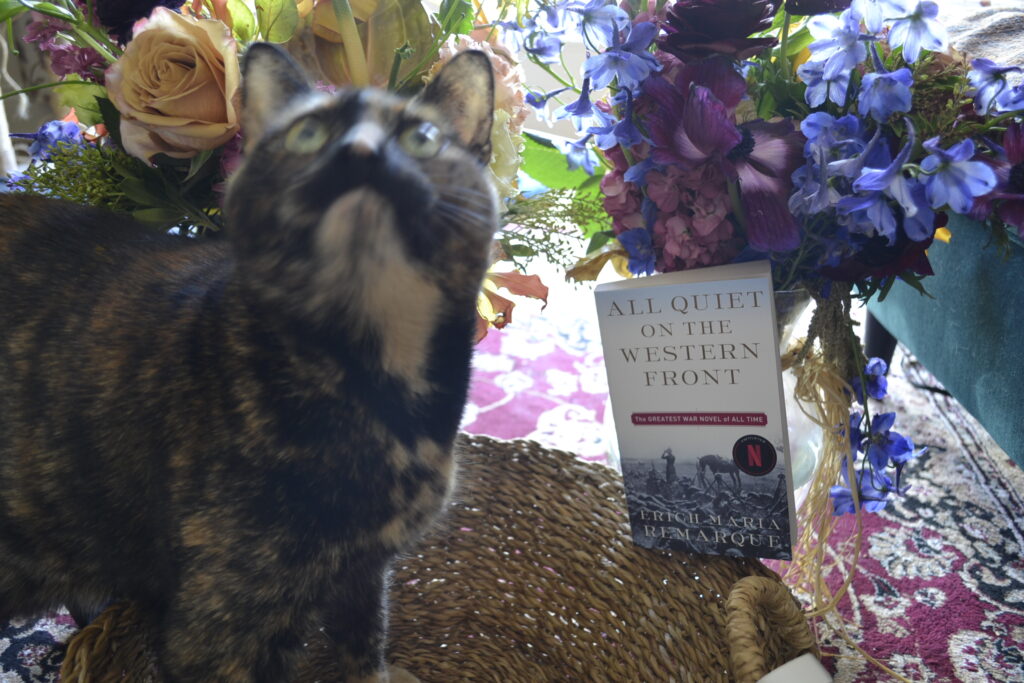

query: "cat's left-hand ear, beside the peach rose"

left=242, top=43, right=310, bottom=150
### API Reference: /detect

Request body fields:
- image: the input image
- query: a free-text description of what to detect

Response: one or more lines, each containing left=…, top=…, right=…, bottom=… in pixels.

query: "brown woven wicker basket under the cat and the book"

left=61, top=436, right=817, bottom=683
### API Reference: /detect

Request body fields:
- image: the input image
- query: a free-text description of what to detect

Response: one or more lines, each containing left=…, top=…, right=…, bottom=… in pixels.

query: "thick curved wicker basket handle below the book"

left=725, top=577, right=819, bottom=683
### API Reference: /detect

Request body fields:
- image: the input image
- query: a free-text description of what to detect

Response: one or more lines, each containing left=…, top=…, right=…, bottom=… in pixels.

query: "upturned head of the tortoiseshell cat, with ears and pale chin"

left=224, top=44, right=497, bottom=325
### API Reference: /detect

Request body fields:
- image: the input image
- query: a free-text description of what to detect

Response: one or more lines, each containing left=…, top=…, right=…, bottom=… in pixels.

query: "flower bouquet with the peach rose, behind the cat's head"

left=0, top=0, right=565, bottom=337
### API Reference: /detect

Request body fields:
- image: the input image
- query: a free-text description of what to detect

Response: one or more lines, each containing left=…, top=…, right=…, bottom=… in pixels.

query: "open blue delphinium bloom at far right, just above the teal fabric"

left=921, top=137, right=996, bottom=214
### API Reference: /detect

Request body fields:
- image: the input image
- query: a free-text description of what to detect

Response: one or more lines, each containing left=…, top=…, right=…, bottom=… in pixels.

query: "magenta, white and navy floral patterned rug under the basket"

left=0, top=296, right=1024, bottom=683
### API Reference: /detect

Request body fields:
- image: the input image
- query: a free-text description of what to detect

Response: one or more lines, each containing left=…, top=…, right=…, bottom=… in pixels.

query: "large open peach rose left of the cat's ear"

left=106, top=7, right=241, bottom=161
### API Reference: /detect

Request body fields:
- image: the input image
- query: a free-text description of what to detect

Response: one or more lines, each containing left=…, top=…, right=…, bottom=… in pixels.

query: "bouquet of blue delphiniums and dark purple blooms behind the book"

left=485, top=0, right=1024, bottom=671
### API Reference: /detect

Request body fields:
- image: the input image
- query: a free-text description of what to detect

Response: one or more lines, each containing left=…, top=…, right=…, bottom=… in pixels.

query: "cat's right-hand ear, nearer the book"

left=419, top=50, right=495, bottom=164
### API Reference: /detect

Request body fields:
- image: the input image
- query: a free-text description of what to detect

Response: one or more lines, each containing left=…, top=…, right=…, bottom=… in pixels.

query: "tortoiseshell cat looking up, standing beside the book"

left=0, top=45, right=497, bottom=683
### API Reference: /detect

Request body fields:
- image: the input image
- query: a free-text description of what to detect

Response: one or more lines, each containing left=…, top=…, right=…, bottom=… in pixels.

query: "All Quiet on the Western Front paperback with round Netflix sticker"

left=595, top=261, right=797, bottom=559
